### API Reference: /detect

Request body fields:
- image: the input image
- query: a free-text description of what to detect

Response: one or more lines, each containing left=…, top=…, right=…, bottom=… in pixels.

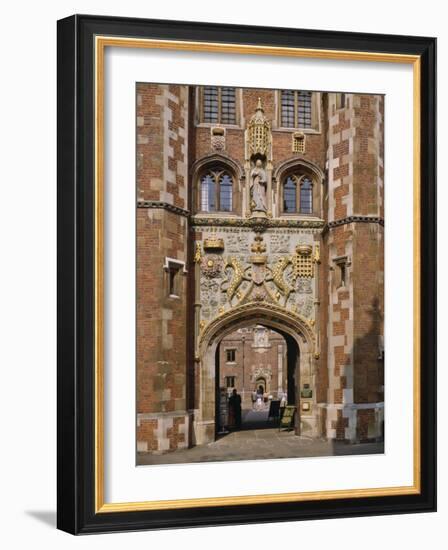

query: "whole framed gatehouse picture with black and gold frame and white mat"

left=58, top=15, right=436, bottom=534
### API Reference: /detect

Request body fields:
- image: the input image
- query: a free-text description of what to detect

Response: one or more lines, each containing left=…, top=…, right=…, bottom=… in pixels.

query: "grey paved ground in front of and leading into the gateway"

left=137, top=411, right=384, bottom=465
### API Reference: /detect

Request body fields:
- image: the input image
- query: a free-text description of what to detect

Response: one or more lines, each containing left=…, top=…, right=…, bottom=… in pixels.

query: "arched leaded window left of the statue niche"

left=200, top=168, right=233, bottom=212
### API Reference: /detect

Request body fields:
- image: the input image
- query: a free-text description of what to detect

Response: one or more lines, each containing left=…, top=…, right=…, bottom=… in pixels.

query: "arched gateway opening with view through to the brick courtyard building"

left=215, top=324, right=300, bottom=435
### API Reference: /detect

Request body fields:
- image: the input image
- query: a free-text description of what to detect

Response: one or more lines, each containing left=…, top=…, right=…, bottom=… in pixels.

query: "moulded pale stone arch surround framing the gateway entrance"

left=194, top=302, right=315, bottom=445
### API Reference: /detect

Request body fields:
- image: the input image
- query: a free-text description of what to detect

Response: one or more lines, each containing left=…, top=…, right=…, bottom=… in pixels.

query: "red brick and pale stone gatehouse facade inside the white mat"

left=136, top=83, right=384, bottom=453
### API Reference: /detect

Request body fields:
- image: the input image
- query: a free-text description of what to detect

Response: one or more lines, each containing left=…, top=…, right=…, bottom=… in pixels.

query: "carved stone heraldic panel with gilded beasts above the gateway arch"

left=195, top=227, right=319, bottom=336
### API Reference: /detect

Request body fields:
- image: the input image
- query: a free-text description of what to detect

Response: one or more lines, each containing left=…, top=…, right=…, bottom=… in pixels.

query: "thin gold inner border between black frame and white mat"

left=94, top=36, right=421, bottom=513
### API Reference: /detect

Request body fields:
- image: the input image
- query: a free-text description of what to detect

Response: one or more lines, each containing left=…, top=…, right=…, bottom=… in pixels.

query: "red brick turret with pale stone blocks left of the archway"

left=137, top=84, right=192, bottom=451
